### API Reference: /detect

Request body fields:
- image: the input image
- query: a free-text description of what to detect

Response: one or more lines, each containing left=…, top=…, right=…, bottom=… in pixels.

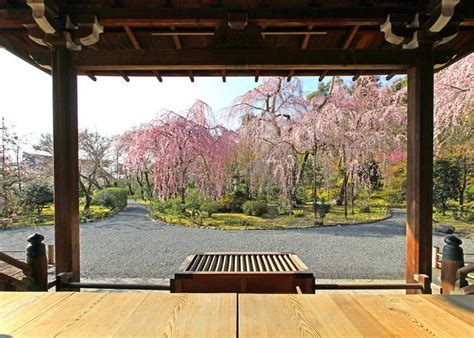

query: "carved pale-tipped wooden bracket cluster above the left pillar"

left=27, top=0, right=104, bottom=50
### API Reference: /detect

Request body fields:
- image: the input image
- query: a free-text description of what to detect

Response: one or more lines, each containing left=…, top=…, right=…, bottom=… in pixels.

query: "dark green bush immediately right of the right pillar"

left=433, top=158, right=461, bottom=214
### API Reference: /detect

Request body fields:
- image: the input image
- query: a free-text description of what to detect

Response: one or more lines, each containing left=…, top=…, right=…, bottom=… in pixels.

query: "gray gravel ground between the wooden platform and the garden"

left=0, top=202, right=474, bottom=279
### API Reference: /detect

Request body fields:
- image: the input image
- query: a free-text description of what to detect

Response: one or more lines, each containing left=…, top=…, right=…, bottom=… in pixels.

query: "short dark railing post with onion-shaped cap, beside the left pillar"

left=26, top=234, right=48, bottom=291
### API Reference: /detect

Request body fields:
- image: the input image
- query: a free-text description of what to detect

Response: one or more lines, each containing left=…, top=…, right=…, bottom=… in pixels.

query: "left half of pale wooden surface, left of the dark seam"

left=0, top=292, right=237, bottom=337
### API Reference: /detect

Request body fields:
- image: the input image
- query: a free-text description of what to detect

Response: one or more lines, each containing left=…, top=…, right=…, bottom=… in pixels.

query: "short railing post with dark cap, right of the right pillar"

left=441, top=236, right=466, bottom=295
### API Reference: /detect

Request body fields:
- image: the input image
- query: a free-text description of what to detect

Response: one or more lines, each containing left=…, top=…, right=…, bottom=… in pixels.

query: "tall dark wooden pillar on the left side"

left=51, top=46, right=80, bottom=281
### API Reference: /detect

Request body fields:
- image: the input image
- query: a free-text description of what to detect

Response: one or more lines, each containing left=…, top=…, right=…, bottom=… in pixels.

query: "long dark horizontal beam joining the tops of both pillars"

left=31, top=48, right=455, bottom=71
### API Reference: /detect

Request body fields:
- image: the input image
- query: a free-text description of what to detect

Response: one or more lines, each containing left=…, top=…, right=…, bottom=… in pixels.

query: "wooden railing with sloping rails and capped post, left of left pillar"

left=0, top=234, right=48, bottom=291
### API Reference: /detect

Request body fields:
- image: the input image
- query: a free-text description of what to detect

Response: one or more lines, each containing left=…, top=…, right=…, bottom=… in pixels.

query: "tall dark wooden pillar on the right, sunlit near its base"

left=406, top=46, right=433, bottom=294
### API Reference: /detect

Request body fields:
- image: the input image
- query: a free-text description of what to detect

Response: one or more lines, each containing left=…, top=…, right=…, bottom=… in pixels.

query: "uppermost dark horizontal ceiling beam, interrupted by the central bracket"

left=0, top=4, right=474, bottom=28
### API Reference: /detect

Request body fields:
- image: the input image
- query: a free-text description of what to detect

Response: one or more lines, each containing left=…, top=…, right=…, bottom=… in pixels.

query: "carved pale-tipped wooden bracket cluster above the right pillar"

left=380, top=0, right=462, bottom=49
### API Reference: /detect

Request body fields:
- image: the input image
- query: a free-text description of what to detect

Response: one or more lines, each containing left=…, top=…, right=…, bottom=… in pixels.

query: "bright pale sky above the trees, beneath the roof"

left=0, top=49, right=317, bottom=140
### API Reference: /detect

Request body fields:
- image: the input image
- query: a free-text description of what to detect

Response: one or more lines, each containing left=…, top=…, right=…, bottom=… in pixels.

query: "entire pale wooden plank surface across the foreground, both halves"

left=0, top=292, right=474, bottom=338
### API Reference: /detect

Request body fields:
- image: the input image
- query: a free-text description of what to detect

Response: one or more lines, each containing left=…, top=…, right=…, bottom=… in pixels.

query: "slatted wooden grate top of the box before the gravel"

left=182, top=253, right=307, bottom=273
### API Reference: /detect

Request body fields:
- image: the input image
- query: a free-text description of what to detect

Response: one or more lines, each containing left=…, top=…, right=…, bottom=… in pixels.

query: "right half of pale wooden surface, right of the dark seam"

left=239, top=294, right=474, bottom=337
